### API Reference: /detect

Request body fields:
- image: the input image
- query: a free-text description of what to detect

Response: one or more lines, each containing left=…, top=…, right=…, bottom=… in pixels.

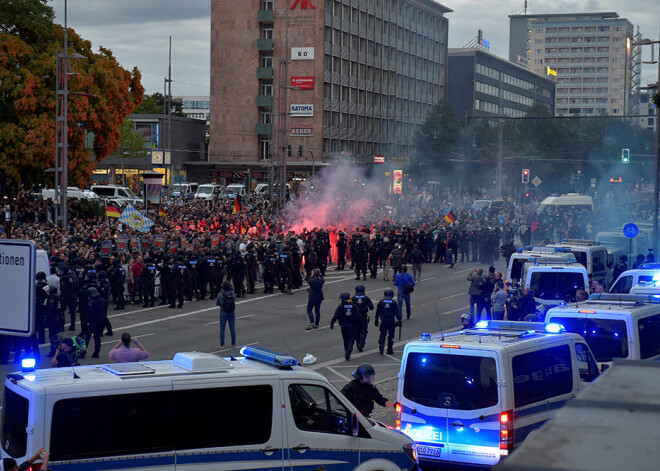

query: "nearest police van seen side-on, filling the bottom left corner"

left=0, top=347, right=419, bottom=471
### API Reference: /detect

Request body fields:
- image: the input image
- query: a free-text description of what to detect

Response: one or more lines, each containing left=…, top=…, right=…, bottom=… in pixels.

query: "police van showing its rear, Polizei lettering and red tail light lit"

left=397, top=321, right=598, bottom=469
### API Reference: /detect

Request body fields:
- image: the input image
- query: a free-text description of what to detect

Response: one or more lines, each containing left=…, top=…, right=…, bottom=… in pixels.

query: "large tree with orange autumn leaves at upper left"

left=0, top=0, right=144, bottom=192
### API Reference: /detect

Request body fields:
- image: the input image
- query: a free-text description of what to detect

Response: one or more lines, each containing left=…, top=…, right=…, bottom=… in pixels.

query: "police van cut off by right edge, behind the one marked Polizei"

left=545, top=293, right=660, bottom=371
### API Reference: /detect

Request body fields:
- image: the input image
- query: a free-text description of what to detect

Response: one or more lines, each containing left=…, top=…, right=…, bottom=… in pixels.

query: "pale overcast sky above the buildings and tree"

left=49, top=0, right=660, bottom=96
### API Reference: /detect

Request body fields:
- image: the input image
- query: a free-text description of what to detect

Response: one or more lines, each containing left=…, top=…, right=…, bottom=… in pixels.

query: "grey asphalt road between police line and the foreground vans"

left=0, top=258, right=504, bottom=424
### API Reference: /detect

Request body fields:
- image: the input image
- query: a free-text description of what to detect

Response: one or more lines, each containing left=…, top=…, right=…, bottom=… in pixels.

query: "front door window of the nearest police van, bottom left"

left=289, top=384, right=351, bottom=435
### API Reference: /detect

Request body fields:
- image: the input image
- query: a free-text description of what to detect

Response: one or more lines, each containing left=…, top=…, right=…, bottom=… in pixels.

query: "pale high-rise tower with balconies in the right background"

left=509, top=12, right=640, bottom=116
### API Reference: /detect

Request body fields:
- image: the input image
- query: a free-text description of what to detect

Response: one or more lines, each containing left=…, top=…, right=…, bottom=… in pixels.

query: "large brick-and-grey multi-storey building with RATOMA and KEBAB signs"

left=209, top=0, right=451, bottom=177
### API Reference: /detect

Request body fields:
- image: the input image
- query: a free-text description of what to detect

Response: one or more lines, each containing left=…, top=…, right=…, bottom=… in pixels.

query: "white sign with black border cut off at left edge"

left=0, top=240, right=37, bottom=337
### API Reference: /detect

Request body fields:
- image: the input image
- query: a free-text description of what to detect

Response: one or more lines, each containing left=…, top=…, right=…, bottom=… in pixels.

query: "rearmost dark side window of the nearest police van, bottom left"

left=49, top=391, right=173, bottom=461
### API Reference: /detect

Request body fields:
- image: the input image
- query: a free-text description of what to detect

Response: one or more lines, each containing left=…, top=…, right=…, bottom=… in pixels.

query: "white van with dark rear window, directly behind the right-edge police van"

left=520, top=257, right=589, bottom=307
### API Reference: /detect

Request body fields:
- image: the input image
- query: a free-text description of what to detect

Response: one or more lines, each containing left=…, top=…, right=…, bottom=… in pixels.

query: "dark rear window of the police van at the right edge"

left=552, top=317, right=628, bottom=362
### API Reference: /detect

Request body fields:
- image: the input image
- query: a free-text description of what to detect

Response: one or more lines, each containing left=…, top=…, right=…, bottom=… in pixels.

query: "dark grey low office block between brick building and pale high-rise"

left=447, top=48, right=555, bottom=119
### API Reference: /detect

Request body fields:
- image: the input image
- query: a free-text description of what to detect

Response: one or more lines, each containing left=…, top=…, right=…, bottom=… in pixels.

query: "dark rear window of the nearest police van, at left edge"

left=1, top=387, right=30, bottom=456
